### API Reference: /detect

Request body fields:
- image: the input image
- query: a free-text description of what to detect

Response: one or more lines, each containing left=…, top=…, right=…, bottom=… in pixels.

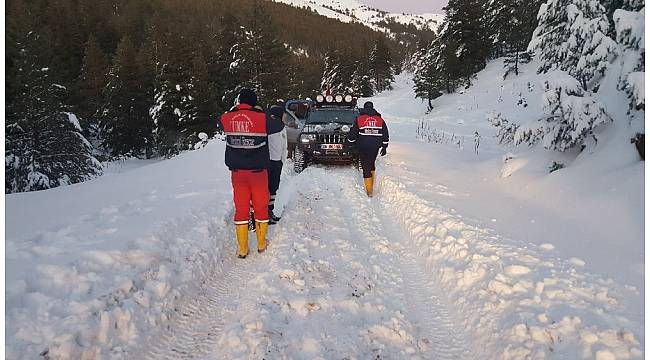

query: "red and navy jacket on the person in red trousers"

left=221, top=104, right=270, bottom=170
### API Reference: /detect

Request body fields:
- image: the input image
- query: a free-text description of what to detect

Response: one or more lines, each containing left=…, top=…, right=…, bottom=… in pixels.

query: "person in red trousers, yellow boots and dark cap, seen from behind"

left=221, top=89, right=270, bottom=259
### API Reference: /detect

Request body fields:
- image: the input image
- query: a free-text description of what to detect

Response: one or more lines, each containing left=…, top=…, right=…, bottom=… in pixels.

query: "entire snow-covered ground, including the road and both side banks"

left=5, top=63, right=645, bottom=359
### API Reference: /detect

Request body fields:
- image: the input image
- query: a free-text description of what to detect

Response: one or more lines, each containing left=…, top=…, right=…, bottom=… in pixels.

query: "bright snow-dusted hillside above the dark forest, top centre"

left=274, top=0, right=444, bottom=31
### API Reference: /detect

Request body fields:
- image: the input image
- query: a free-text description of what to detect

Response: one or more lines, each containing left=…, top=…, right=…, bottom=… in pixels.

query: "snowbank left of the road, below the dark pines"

left=5, top=140, right=235, bottom=359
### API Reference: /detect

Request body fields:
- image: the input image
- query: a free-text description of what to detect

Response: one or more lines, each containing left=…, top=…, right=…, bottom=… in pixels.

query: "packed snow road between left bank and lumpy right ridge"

left=143, top=167, right=470, bottom=359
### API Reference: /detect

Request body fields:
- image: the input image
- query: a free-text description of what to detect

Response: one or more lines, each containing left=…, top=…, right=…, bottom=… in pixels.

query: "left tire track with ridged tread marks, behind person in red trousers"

left=138, top=169, right=306, bottom=359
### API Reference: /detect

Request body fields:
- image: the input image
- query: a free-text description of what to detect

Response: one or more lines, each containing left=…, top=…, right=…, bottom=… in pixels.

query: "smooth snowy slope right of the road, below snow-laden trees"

left=372, top=67, right=644, bottom=296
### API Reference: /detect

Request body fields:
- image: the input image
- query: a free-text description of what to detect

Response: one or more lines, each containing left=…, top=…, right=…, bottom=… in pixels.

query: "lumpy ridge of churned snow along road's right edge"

left=379, top=176, right=643, bottom=359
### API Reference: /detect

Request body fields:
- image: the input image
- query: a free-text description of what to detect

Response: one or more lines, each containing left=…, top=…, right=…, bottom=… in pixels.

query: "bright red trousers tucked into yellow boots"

left=231, top=170, right=269, bottom=224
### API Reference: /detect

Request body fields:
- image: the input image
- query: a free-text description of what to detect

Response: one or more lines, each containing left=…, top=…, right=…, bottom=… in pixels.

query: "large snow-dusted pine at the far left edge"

left=5, top=28, right=101, bottom=193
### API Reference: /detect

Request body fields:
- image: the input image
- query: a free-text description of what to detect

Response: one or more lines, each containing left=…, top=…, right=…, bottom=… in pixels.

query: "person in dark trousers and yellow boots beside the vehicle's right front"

left=348, top=101, right=388, bottom=197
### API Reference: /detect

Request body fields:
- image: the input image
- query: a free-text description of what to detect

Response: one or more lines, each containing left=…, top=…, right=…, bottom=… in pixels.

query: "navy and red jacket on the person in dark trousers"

left=348, top=109, right=388, bottom=149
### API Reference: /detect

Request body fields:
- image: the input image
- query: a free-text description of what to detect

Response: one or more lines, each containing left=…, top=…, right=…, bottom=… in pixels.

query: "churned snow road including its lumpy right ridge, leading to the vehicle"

left=130, top=162, right=642, bottom=359
